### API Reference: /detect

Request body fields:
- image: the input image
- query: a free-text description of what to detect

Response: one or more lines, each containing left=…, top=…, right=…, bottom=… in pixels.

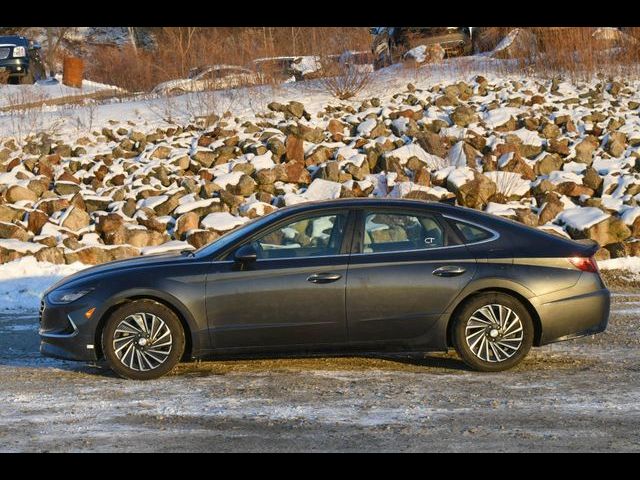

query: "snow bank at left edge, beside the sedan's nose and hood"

left=0, top=257, right=89, bottom=313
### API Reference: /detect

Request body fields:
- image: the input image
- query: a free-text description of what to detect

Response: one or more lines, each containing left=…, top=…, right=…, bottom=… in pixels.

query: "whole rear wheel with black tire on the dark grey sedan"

left=452, top=292, right=534, bottom=372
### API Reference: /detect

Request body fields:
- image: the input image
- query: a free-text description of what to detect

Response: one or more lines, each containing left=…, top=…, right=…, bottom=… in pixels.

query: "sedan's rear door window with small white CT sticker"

left=363, top=212, right=448, bottom=253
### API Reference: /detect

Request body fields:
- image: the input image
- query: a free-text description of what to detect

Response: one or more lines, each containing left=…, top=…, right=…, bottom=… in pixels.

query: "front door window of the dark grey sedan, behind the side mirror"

left=252, top=213, right=346, bottom=260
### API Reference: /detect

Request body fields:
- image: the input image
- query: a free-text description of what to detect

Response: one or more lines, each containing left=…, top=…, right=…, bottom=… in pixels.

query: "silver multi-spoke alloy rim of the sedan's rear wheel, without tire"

left=465, top=304, right=524, bottom=363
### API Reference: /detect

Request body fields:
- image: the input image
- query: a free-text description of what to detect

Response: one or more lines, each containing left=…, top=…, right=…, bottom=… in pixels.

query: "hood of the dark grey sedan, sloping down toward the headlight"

left=44, top=252, right=189, bottom=295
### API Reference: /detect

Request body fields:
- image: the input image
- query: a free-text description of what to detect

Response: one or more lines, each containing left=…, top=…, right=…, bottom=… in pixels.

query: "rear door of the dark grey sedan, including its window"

left=346, top=208, right=476, bottom=344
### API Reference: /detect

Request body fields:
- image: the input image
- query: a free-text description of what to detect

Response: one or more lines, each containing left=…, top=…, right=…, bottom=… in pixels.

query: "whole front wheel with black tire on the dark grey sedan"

left=101, top=300, right=185, bottom=380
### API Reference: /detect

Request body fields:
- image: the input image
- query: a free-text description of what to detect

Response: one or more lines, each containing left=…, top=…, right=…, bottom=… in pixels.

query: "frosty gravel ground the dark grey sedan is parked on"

left=0, top=289, right=640, bottom=452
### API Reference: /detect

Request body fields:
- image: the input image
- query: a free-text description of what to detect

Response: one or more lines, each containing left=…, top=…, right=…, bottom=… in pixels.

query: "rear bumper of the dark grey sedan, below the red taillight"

left=532, top=274, right=611, bottom=345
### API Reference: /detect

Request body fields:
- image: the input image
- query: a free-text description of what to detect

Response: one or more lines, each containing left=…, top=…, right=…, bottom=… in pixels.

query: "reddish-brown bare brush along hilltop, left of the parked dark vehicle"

left=87, top=27, right=371, bottom=91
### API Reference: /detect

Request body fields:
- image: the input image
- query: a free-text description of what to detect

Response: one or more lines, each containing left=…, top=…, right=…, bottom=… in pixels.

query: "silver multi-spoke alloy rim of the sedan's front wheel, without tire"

left=112, top=312, right=173, bottom=372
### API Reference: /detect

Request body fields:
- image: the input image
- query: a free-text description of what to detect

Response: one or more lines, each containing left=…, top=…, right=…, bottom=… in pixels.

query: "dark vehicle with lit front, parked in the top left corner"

left=0, top=35, right=46, bottom=84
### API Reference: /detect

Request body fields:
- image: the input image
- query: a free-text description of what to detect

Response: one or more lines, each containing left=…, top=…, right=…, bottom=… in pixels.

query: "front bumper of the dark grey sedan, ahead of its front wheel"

left=38, top=297, right=97, bottom=361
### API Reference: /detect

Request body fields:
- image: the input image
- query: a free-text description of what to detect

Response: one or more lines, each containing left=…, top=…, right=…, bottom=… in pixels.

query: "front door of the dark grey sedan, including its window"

left=206, top=210, right=353, bottom=349
